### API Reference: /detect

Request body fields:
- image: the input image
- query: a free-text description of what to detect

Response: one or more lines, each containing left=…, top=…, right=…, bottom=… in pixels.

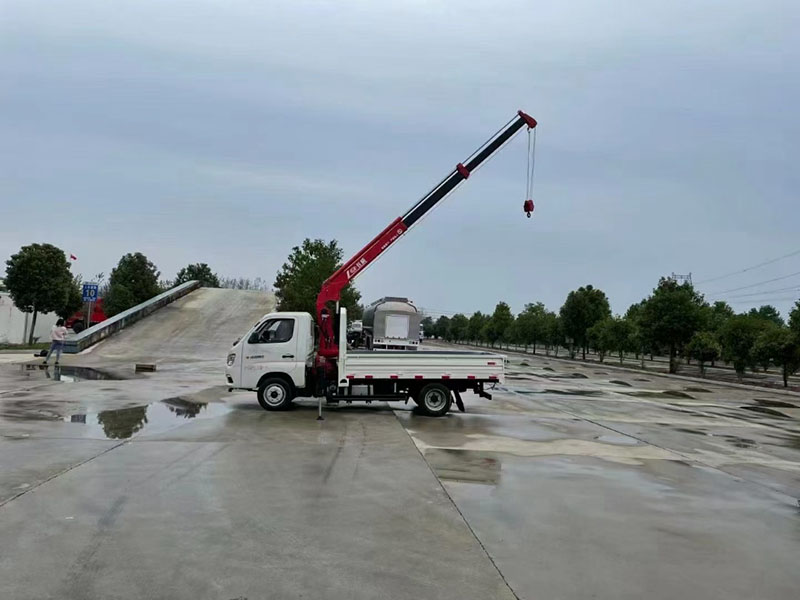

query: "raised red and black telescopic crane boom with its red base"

left=316, top=110, right=536, bottom=357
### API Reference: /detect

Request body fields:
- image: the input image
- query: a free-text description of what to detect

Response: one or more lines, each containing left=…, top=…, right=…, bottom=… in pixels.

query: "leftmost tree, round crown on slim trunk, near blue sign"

left=5, top=244, right=73, bottom=344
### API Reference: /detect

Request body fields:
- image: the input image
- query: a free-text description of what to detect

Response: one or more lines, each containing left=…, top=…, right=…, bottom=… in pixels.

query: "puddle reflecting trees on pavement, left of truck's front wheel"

left=63, top=398, right=231, bottom=440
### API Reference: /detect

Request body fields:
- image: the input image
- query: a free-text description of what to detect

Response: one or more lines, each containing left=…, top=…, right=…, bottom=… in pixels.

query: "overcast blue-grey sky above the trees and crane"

left=0, top=0, right=800, bottom=314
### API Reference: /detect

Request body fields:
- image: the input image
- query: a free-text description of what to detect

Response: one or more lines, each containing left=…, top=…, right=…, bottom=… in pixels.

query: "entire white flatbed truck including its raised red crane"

left=226, top=111, right=536, bottom=416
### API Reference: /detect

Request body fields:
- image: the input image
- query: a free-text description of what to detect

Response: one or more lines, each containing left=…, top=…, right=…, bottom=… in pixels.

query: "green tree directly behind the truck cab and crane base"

left=274, top=238, right=361, bottom=319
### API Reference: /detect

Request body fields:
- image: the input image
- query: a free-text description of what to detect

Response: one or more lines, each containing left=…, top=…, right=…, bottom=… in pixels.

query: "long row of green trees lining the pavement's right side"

left=423, top=277, right=800, bottom=386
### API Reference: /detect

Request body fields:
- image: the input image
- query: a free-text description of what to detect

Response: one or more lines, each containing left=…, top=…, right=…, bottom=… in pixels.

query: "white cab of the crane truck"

left=225, top=312, right=315, bottom=395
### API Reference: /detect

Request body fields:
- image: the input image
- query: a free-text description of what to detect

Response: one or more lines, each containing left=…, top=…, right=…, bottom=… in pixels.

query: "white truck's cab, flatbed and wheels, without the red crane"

left=226, top=309, right=504, bottom=417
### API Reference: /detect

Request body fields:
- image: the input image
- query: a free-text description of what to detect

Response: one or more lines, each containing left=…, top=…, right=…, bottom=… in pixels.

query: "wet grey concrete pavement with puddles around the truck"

left=0, top=312, right=800, bottom=600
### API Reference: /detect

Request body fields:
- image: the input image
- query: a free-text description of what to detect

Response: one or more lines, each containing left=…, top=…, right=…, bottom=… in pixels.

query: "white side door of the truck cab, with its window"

left=242, top=317, right=306, bottom=388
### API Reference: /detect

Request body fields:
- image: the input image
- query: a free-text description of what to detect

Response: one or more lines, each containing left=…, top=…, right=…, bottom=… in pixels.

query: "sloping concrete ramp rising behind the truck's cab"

left=81, top=288, right=275, bottom=370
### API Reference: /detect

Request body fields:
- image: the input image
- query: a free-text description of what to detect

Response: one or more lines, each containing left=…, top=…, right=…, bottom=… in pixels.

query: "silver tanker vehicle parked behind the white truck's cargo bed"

left=363, top=296, right=422, bottom=350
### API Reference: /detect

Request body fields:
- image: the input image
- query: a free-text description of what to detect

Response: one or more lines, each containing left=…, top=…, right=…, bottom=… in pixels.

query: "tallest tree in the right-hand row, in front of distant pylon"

left=639, top=277, right=707, bottom=373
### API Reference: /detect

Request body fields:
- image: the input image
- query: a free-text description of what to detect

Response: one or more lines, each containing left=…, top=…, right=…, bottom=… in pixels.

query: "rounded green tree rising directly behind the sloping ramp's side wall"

left=103, top=252, right=161, bottom=317
